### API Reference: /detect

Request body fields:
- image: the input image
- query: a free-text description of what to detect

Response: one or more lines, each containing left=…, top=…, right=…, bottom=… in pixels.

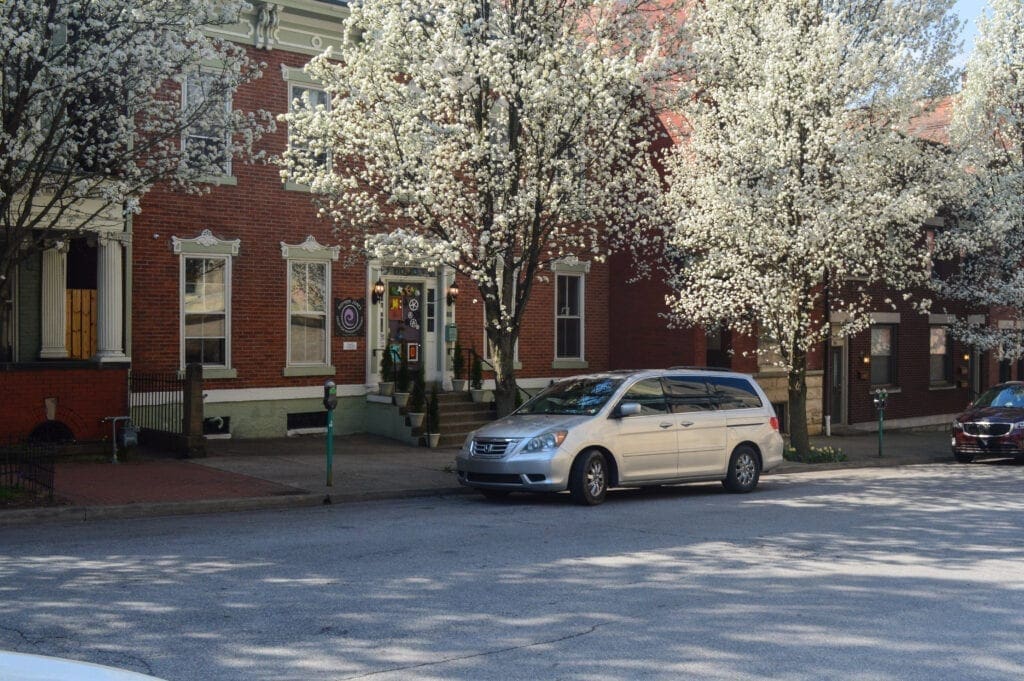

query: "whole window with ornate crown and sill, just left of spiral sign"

left=281, top=237, right=340, bottom=368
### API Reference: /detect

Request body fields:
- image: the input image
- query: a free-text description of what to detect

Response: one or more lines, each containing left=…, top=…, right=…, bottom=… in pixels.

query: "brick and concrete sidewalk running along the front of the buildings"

left=0, top=431, right=952, bottom=526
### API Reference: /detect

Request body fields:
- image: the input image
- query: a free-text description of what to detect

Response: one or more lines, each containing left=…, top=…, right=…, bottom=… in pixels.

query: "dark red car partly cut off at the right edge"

left=950, top=381, right=1024, bottom=464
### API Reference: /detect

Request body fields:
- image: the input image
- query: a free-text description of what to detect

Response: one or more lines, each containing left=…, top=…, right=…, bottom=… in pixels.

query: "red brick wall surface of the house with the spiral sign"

left=132, top=50, right=609, bottom=389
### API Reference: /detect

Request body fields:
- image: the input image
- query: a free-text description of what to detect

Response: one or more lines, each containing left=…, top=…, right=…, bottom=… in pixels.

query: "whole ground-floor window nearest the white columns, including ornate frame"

left=171, top=229, right=241, bottom=378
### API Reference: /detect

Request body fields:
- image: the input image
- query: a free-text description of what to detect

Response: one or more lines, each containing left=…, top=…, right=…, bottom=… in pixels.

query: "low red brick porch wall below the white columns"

left=0, top=367, right=128, bottom=440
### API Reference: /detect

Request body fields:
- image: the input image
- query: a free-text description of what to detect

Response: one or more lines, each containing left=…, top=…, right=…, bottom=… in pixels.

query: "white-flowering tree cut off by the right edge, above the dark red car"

left=934, top=0, right=1024, bottom=358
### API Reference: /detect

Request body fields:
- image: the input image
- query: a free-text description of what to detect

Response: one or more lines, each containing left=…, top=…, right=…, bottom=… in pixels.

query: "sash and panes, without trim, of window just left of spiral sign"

left=288, top=260, right=329, bottom=365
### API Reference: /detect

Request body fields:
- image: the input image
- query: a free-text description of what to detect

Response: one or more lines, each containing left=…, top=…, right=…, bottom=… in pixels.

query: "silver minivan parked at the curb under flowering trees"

left=456, top=368, right=782, bottom=505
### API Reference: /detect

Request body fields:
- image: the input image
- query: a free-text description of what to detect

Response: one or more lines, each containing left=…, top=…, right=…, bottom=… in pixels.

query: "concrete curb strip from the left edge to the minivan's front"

left=0, top=486, right=471, bottom=527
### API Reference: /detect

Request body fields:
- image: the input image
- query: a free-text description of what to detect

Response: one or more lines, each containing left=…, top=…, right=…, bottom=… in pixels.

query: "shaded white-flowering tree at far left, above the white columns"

left=0, top=0, right=262, bottom=358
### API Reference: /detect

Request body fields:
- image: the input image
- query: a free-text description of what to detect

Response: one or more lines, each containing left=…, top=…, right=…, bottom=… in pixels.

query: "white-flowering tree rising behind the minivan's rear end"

left=667, top=0, right=956, bottom=454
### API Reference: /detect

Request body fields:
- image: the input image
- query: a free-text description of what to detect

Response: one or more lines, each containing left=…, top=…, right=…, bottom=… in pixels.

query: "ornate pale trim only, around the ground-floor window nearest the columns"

left=171, top=229, right=242, bottom=379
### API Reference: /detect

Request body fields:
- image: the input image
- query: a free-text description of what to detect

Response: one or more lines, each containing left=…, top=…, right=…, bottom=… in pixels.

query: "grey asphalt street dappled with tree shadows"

left=0, top=463, right=1024, bottom=681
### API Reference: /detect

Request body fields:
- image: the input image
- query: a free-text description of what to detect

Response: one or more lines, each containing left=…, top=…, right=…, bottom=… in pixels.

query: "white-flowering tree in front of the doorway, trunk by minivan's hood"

left=284, top=0, right=673, bottom=414
